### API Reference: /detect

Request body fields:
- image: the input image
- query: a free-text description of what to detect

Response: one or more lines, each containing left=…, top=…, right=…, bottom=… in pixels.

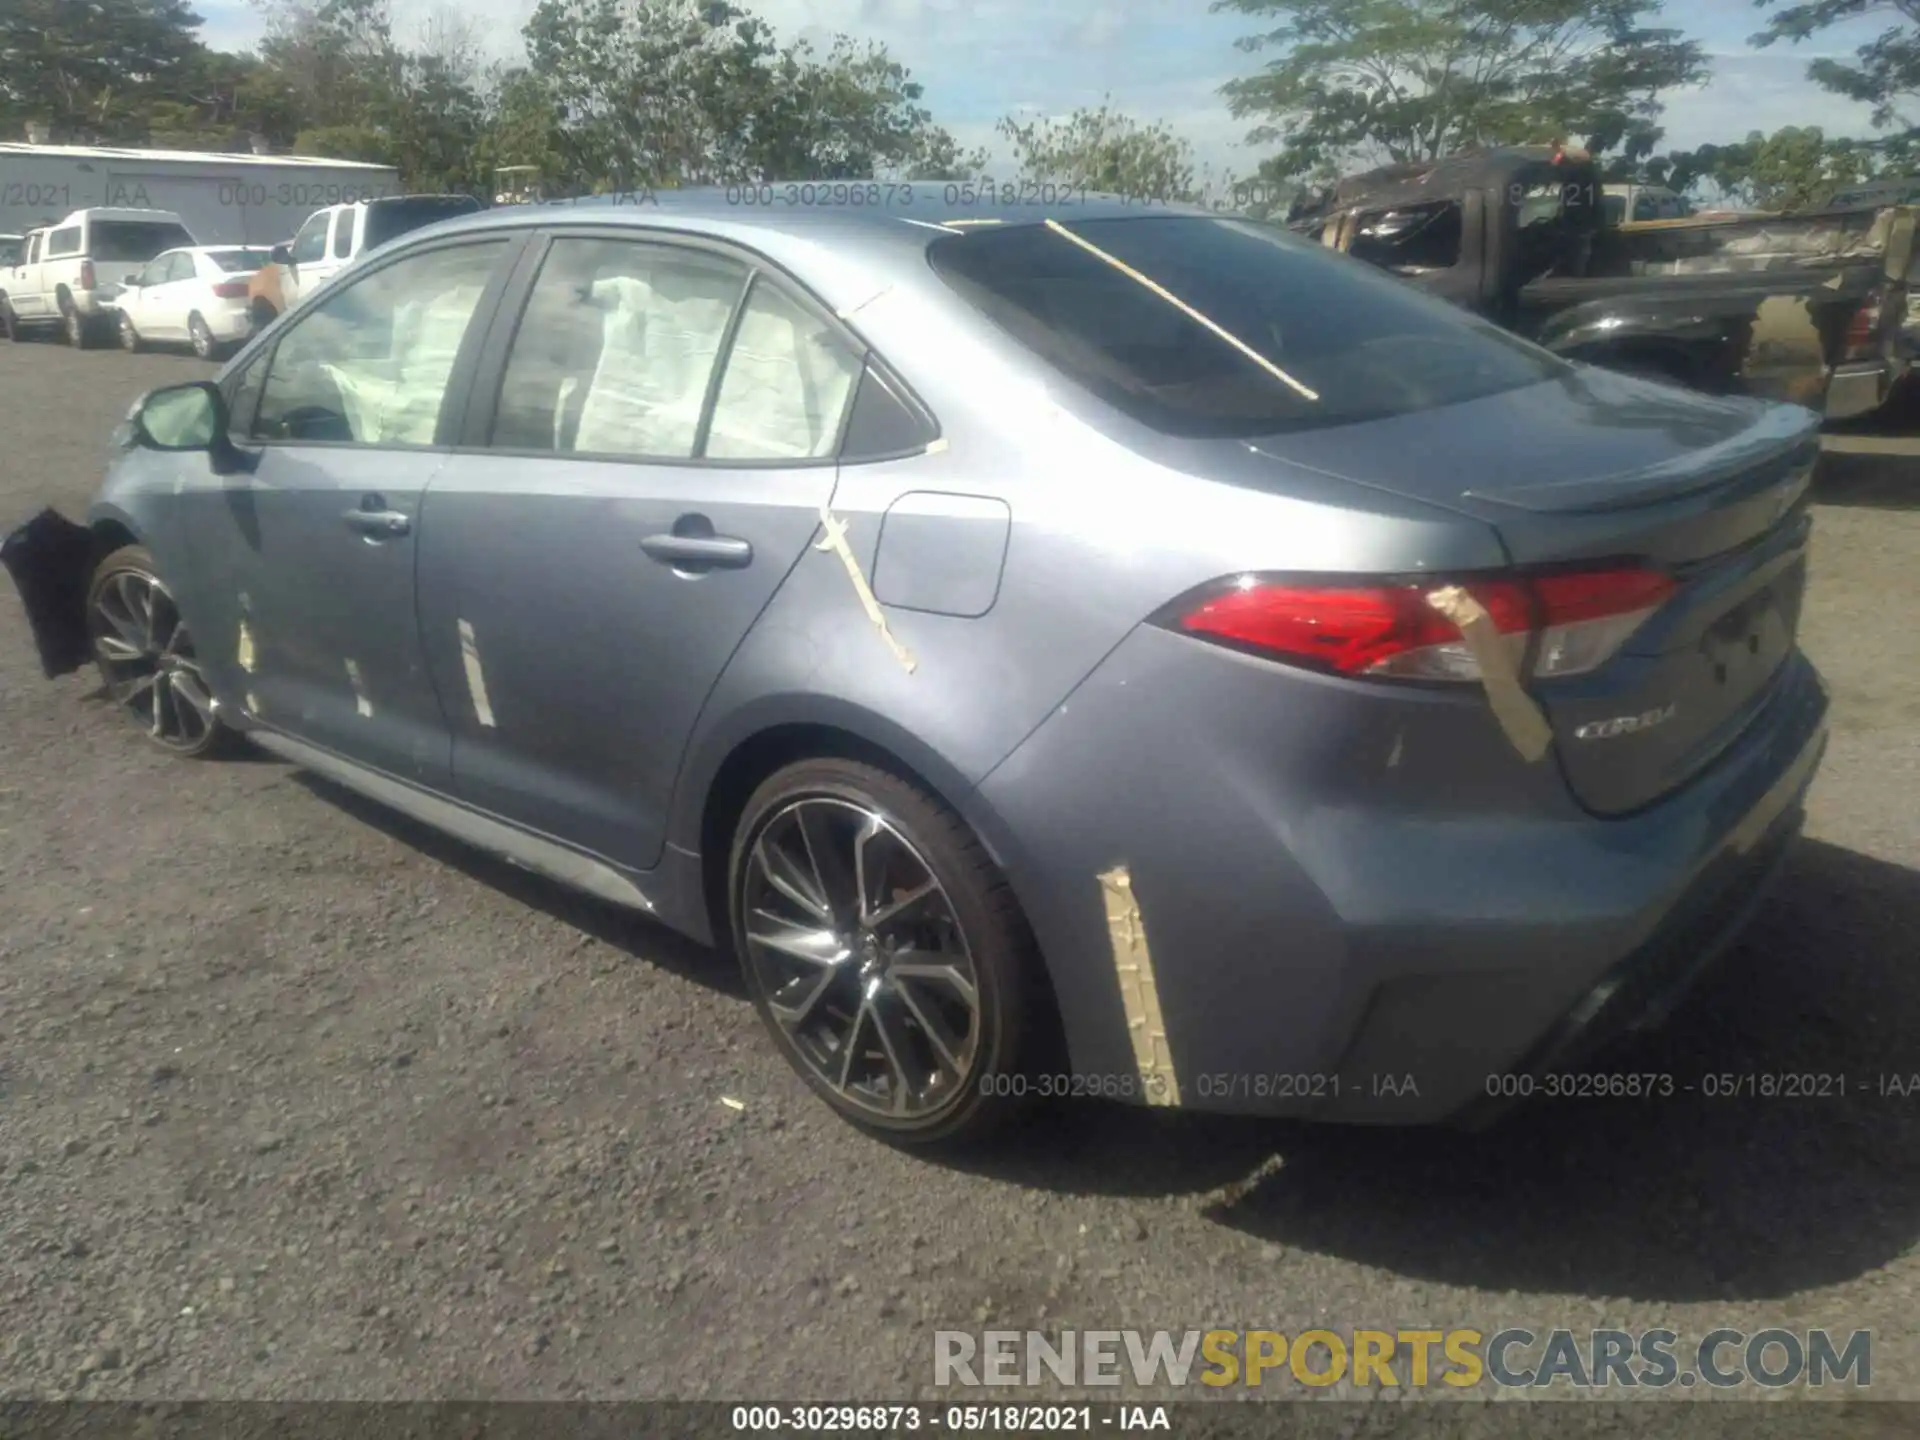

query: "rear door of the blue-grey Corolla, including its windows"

left=420, top=230, right=860, bottom=870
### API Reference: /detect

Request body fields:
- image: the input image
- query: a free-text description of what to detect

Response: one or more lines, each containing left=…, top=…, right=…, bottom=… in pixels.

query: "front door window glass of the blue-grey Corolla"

left=253, top=240, right=507, bottom=445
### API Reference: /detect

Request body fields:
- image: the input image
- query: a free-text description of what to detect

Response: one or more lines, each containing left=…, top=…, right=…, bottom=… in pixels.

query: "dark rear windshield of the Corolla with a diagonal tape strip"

left=927, top=215, right=1567, bottom=438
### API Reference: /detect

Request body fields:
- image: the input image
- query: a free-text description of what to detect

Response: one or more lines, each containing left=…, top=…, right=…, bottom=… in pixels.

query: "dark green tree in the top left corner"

left=0, top=0, right=202, bottom=142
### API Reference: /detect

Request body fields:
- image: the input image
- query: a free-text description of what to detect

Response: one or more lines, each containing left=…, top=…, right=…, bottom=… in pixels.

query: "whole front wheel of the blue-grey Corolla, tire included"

left=86, top=545, right=238, bottom=760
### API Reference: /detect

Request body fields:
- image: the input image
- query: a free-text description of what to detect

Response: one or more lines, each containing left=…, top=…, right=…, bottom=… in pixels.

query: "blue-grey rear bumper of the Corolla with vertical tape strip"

left=979, top=632, right=1826, bottom=1123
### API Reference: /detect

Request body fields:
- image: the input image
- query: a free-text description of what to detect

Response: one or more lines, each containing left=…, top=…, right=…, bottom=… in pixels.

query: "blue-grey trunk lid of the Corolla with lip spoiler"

left=1256, top=369, right=1818, bottom=816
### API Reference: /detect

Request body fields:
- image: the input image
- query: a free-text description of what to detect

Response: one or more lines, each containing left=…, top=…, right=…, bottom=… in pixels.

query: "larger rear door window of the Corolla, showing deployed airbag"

left=492, top=236, right=749, bottom=459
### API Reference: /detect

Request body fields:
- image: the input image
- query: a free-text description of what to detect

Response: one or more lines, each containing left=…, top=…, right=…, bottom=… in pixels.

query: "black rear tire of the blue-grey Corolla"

left=728, top=758, right=1048, bottom=1146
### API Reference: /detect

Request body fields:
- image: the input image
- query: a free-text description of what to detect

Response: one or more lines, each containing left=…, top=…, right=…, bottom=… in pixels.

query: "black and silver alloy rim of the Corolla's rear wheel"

left=741, top=797, right=981, bottom=1121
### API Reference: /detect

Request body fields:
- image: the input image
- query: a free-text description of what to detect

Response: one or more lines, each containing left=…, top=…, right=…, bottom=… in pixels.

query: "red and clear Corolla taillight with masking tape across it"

left=1167, top=568, right=1674, bottom=680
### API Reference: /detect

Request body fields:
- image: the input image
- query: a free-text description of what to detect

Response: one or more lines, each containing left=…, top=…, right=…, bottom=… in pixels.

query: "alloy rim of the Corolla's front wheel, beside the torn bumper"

left=88, top=570, right=213, bottom=751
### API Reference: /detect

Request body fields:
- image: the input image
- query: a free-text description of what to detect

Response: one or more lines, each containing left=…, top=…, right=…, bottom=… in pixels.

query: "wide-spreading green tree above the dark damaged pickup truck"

left=1212, top=0, right=1707, bottom=179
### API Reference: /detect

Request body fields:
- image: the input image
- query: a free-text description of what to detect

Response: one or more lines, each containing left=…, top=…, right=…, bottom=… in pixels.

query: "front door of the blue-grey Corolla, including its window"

left=182, top=236, right=518, bottom=789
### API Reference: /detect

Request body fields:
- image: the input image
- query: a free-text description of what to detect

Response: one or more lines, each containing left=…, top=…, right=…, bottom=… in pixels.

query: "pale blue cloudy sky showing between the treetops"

left=187, top=0, right=1885, bottom=173
